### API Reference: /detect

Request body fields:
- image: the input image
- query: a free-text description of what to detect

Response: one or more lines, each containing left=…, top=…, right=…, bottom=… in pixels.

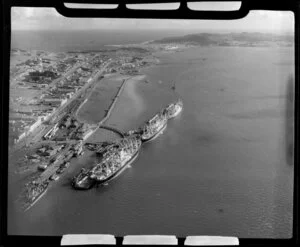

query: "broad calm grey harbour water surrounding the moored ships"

left=8, top=30, right=294, bottom=238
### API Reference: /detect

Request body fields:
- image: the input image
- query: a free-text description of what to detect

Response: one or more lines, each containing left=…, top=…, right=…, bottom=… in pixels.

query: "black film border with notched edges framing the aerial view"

left=0, top=0, right=300, bottom=246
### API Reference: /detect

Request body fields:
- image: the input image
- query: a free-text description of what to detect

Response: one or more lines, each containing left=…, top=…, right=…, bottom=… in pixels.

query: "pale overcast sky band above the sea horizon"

left=11, top=3, right=294, bottom=33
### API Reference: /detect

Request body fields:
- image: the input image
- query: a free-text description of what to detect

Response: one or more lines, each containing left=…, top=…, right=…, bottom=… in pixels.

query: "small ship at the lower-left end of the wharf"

left=25, top=181, right=49, bottom=211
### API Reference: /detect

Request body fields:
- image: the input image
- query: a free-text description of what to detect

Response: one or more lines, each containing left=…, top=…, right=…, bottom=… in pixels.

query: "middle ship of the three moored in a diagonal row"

left=141, top=112, right=168, bottom=142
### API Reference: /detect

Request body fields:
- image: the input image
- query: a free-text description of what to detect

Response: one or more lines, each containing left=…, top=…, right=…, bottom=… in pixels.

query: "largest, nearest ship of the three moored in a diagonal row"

left=90, top=135, right=142, bottom=184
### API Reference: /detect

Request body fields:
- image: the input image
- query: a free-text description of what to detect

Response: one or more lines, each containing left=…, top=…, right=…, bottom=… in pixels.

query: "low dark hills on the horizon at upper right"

left=151, top=32, right=294, bottom=46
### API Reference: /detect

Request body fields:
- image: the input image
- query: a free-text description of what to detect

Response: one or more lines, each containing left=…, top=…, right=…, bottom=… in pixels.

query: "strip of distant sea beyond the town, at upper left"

left=11, top=30, right=186, bottom=52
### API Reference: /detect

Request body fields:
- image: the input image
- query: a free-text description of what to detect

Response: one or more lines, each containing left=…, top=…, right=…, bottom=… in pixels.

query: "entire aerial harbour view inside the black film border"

left=7, top=2, right=295, bottom=239
